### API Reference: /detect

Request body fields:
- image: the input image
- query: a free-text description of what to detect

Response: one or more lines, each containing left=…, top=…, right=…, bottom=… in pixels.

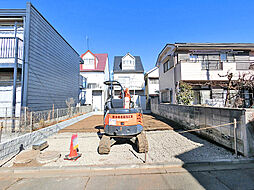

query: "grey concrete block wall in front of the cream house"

left=151, top=100, right=254, bottom=156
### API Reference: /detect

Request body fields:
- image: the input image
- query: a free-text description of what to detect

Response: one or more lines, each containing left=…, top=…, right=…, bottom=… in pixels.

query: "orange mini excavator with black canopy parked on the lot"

left=98, top=81, right=148, bottom=154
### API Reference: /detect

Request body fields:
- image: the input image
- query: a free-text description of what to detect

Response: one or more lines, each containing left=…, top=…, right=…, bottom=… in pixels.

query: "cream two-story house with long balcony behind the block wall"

left=156, top=43, right=254, bottom=107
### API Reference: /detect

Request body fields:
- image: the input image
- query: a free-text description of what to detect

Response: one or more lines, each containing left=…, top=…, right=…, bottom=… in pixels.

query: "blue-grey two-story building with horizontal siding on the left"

left=0, top=3, right=81, bottom=121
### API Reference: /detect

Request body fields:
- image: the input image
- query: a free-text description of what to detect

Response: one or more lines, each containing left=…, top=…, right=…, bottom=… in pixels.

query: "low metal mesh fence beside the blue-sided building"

left=0, top=106, right=92, bottom=142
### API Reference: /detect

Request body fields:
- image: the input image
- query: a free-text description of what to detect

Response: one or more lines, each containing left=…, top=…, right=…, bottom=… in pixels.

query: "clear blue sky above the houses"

left=0, top=0, right=254, bottom=71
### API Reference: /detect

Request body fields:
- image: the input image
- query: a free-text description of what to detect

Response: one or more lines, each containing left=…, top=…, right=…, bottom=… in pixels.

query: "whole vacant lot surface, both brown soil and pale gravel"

left=5, top=115, right=238, bottom=167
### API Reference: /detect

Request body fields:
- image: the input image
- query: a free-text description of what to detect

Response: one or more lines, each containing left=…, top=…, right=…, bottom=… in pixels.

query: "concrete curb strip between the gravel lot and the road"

left=0, top=159, right=254, bottom=178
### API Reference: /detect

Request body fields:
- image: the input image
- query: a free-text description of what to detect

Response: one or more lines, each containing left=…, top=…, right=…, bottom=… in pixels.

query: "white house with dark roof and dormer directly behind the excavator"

left=113, top=53, right=145, bottom=109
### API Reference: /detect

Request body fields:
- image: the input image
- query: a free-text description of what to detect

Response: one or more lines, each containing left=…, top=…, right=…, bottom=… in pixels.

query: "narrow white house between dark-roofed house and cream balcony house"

left=145, top=67, right=159, bottom=109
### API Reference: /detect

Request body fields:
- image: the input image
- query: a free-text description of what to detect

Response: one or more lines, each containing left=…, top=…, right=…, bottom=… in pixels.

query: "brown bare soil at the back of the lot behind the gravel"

left=59, top=114, right=173, bottom=133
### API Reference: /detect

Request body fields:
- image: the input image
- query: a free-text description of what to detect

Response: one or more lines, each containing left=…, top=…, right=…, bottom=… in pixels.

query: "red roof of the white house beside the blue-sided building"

left=80, top=50, right=108, bottom=72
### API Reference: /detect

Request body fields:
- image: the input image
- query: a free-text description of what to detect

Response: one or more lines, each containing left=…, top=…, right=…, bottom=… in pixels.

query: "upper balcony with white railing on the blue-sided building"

left=0, top=37, right=23, bottom=68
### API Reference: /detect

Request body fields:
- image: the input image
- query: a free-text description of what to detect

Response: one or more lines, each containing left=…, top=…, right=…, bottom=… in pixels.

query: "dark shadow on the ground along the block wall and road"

left=149, top=115, right=254, bottom=189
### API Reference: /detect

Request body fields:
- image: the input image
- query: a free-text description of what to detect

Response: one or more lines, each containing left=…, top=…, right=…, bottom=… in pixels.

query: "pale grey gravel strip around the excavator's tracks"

left=38, top=130, right=237, bottom=167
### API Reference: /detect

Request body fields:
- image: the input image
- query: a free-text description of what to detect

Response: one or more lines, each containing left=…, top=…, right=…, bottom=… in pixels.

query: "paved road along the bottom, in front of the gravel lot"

left=0, top=163, right=254, bottom=190
